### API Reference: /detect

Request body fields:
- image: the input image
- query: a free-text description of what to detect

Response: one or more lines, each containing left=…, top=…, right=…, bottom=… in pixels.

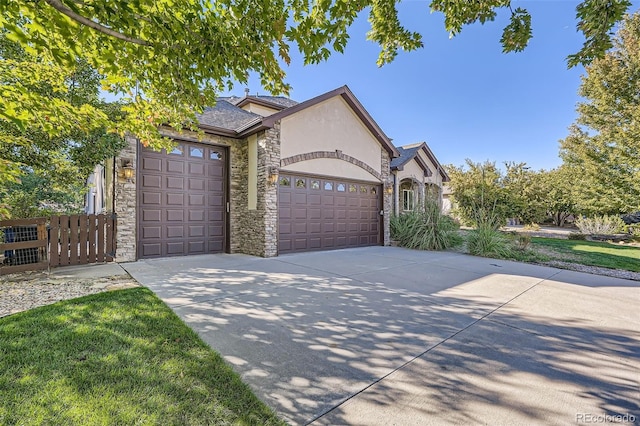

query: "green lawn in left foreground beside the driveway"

left=0, top=288, right=284, bottom=425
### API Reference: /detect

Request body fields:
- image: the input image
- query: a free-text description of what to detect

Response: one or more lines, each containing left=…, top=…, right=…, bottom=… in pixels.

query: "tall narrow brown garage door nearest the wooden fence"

left=138, top=142, right=227, bottom=258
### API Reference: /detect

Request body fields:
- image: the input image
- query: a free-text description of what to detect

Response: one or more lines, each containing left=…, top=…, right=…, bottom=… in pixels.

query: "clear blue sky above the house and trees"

left=222, top=0, right=638, bottom=169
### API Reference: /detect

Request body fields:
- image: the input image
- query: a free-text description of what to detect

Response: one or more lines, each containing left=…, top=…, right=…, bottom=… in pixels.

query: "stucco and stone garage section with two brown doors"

left=105, top=86, right=399, bottom=261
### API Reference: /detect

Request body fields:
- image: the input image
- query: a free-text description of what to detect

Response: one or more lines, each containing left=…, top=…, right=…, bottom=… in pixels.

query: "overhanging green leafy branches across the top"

left=0, top=0, right=630, bottom=155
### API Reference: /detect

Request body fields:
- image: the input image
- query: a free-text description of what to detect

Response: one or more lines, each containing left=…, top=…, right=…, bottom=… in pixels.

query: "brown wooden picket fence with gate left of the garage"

left=0, top=214, right=116, bottom=275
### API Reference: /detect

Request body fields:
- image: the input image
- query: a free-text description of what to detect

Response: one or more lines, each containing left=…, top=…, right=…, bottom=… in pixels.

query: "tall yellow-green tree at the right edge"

left=560, top=13, right=640, bottom=214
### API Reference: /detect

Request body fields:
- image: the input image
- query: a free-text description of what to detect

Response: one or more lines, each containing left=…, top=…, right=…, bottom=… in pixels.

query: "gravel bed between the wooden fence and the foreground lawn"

left=0, top=271, right=140, bottom=318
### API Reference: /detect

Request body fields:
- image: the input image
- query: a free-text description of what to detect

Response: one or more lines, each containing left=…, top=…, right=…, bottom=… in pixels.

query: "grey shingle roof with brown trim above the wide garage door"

left=198, top=86, right=400, bottom=158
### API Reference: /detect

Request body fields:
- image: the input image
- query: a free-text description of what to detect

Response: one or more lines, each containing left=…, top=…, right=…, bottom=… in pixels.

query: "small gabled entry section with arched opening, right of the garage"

left=391, top=142, right=450, bottom=214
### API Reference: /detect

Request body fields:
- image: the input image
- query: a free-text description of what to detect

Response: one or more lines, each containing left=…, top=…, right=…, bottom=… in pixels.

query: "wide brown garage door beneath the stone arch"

left=278, top=173, right=382, bottom=254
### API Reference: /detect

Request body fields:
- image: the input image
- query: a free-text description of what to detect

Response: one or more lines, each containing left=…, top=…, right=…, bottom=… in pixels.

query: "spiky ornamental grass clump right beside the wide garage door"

left=391, top=199, right=462, bottom=250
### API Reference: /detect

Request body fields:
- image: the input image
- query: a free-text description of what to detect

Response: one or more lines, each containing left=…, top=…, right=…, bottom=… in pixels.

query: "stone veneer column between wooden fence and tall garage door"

left=113, top=135, right=138, bottom=262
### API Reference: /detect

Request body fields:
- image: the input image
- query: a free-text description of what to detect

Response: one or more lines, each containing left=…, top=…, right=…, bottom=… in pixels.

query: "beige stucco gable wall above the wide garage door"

left=280, top=96, right=382, bottom=180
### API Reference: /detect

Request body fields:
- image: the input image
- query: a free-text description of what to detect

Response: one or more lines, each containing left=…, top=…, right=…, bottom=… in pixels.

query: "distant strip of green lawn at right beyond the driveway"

left=531, top=237, right=640, bottom=272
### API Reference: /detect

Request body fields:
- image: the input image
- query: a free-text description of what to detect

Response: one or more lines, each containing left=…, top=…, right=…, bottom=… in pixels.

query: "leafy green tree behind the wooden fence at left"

left=0, top=32, right=124, bottom=217
